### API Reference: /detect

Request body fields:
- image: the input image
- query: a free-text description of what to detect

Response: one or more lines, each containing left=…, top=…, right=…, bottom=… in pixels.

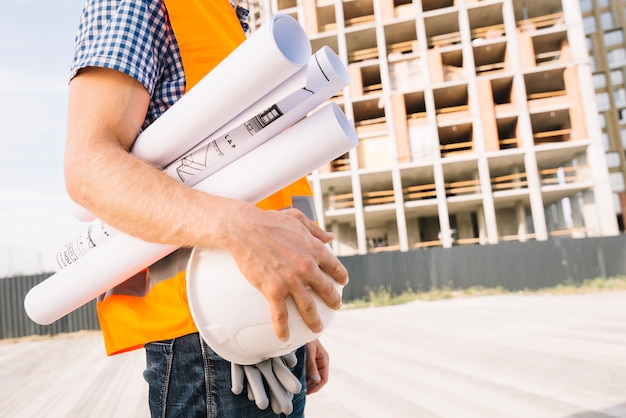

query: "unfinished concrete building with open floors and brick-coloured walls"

left=263, top=0, right=618, bottom=255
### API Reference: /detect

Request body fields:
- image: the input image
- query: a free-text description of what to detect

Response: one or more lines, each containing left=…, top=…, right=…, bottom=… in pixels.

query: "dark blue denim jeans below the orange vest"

left=143, top=333, right=306, bottom=418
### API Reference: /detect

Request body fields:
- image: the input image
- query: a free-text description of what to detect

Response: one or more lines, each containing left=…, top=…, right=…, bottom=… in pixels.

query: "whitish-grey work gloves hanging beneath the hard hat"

left=230, top=351, right=302, bottom=415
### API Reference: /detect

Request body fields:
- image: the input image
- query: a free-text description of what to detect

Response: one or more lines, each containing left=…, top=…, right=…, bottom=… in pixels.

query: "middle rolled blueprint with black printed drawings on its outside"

left=56, top=46, right=350, bottom=268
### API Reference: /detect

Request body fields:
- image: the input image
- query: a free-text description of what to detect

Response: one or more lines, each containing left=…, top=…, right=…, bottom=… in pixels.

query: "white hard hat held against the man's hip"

left=187, top=247, right=342, bottom=365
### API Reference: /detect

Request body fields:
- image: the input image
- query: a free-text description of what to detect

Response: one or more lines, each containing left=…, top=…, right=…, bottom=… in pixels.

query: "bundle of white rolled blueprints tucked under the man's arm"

left=24, top=15, right=357, bottom=325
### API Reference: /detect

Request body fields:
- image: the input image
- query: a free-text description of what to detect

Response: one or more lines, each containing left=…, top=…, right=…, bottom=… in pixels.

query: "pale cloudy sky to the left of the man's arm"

left=0, top=0, right=86, bottom=277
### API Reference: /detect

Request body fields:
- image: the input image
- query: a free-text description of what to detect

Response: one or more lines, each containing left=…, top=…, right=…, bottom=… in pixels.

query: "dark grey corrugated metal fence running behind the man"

left=0, top=235, right=626, bottom=339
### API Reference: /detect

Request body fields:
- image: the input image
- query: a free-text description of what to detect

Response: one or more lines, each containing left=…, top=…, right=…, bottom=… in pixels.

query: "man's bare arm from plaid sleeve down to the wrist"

left=65, top=69, right=238, bottom=250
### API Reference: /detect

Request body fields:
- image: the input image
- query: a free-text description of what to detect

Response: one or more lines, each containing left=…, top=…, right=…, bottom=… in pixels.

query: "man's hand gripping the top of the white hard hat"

left=218, top=205, right=348, bottom=341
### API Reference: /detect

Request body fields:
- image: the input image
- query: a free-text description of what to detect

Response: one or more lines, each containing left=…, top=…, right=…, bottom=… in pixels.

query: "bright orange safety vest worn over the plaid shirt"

left=97, top=0, right=314, bottom=355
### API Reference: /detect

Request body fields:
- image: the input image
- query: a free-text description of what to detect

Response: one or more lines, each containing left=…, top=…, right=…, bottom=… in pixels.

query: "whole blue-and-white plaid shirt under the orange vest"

left=70, top=0, right=248, bottom=129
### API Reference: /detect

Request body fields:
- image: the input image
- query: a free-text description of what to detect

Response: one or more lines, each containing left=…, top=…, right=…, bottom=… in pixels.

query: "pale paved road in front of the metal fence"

left=0, top=292, right=626, bottom=418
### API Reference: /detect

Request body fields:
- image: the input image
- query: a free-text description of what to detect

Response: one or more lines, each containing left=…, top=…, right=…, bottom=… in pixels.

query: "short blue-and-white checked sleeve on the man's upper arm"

left=70, top=0, right=168, bottom=94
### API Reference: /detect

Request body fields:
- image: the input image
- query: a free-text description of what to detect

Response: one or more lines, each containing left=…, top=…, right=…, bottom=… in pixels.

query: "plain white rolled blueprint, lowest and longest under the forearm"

left=24, top=103, right=357, bottom=325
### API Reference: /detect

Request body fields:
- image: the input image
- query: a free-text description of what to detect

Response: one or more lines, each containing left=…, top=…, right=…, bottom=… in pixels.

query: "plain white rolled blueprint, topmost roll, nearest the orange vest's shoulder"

left=131, top=14, right=311, bottom=167
